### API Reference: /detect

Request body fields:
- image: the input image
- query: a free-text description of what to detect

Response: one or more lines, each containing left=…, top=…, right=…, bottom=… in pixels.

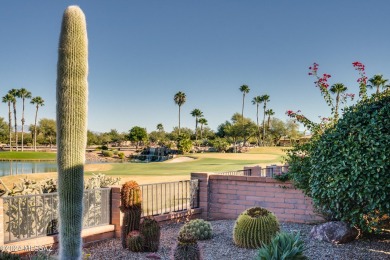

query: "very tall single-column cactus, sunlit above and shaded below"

left=57, top=6, right=88, bottom=259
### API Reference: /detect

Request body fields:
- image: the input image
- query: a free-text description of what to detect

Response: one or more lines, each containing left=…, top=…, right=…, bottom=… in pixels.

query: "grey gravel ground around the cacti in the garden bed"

left=80, top=220, right=390, bottom=260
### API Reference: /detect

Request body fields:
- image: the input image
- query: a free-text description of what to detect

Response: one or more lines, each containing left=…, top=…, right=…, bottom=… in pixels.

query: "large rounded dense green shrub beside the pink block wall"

left=310, top=91, right=390, bottom=232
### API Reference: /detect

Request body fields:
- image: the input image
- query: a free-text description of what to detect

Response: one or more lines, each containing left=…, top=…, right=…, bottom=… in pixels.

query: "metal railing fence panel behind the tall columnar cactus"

left=2, top=188, right=111, bottom=243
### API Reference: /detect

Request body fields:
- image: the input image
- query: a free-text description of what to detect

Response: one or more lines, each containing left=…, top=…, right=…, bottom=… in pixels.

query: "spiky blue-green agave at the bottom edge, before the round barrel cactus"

left=257, top=232, right=307, bottom=260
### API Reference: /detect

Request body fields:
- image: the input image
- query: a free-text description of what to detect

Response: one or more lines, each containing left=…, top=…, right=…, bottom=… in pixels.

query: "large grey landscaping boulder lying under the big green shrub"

left=310, top=221, right=359, bottom=244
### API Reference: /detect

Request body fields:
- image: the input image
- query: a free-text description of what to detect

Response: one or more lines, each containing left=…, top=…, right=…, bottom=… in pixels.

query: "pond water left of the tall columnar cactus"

left=0, top=161, right=57, bottom=177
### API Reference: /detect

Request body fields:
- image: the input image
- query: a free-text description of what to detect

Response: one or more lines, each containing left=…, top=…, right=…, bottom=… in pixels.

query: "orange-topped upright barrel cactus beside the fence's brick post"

left=120, top=181, right=142, bottom=248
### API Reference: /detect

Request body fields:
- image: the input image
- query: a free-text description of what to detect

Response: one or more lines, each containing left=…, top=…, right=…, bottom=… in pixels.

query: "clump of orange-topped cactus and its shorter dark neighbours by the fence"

left=120, top=181, right=160, bottom=252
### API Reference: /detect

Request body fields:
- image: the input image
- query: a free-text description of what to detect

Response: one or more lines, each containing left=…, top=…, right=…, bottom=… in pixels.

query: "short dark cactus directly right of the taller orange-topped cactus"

left=140, top=218, right=160, bottom=252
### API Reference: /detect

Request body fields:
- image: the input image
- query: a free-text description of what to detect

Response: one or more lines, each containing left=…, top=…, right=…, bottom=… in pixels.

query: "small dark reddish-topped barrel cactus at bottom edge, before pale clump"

left=173, top=232, right=201, bottom=260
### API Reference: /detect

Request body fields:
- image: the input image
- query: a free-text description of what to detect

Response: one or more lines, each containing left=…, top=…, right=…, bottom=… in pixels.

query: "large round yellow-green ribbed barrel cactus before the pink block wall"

left=233, top=207, right=279, bottom=248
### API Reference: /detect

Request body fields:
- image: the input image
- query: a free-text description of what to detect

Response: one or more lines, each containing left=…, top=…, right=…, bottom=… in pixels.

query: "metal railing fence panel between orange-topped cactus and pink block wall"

left=140, top=180, right=199, bottom=216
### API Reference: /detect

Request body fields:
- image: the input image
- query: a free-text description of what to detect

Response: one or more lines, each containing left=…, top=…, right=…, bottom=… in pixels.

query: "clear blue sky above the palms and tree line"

left=0, top=0, right=390, bottom=132
